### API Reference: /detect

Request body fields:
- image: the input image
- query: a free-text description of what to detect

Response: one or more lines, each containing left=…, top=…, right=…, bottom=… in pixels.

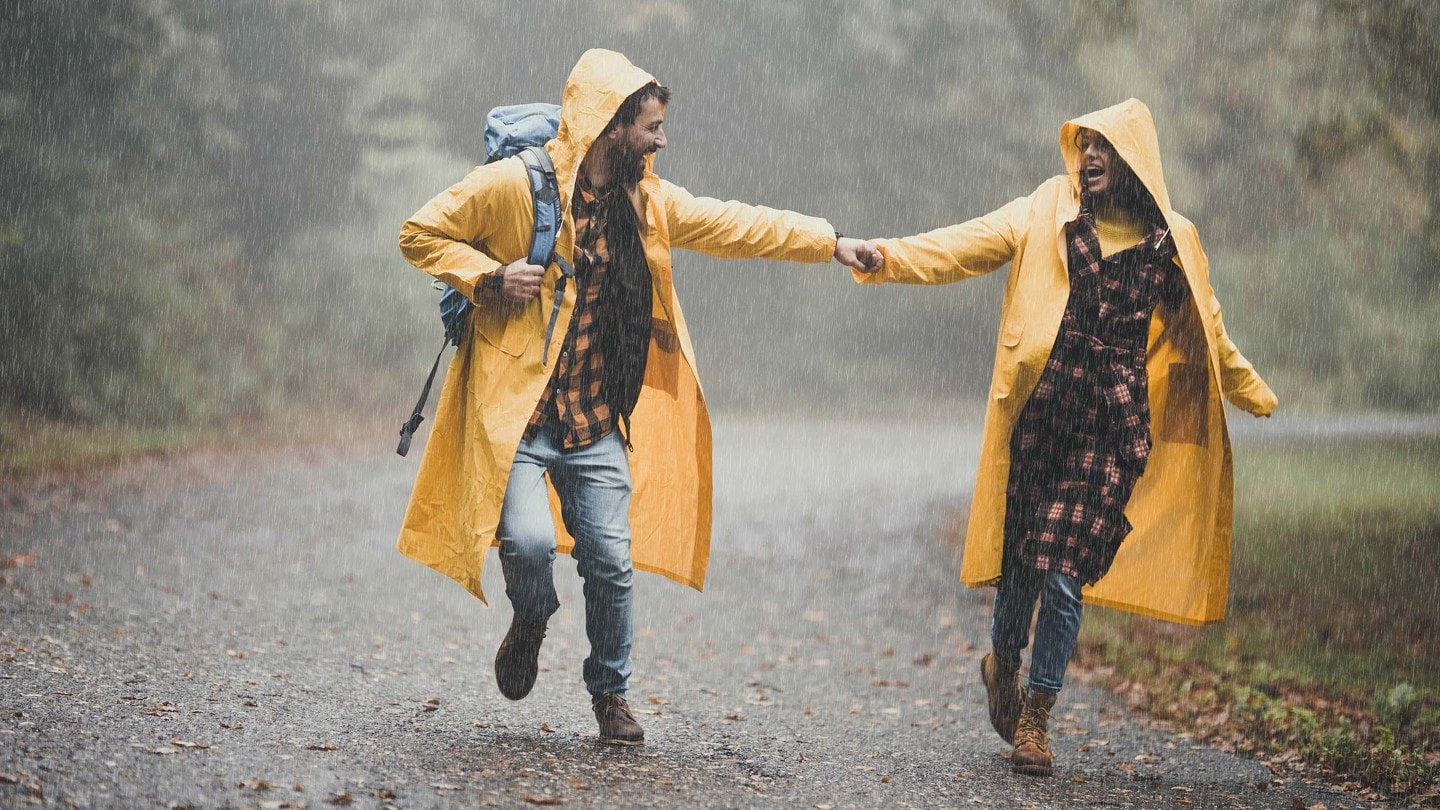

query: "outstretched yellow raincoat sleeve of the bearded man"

left=661, top=180, right=835, bottom=262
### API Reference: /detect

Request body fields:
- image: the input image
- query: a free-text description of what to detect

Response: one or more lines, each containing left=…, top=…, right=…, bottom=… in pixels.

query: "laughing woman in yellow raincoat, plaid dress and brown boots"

left=857, top=98, right=1276, bottom=775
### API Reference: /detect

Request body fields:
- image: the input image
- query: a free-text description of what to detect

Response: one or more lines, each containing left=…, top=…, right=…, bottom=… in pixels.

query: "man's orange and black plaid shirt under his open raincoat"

left=524, top=176, right=621, bottom=450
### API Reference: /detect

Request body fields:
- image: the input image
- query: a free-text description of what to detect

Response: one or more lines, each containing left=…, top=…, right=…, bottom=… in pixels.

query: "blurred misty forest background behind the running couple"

left=0, top=0, right=1440, bottom=435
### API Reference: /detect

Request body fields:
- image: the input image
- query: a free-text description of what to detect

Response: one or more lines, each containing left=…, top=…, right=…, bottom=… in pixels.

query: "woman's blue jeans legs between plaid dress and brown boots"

left=991, top=561, right=1084, bottom=695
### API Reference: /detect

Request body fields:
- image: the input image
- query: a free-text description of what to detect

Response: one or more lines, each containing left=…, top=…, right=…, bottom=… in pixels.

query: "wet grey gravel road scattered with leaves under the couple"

left=0, top=421, right=1348, bottom=809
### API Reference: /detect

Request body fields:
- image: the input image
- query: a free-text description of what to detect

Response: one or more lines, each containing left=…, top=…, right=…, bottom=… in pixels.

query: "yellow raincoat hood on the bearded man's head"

left=549, top=48, right=655, bottom=210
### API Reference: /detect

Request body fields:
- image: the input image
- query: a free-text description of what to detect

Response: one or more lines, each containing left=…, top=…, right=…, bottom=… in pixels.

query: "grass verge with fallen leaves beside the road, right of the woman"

left=1077, top=438, right=1440, bottom=800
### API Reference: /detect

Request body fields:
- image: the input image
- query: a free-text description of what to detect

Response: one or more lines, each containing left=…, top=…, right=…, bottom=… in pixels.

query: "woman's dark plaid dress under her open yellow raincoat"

left=1005, top=208, right=1188, bottom=584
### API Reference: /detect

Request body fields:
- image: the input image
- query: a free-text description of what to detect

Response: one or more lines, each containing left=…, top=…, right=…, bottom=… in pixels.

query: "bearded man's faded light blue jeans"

left=498, top=421, right=634, bottom=698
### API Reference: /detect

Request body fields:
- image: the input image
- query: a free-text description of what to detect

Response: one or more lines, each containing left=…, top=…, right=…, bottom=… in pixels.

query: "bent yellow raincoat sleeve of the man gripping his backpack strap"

left=400, top=163, right=524, bottom=301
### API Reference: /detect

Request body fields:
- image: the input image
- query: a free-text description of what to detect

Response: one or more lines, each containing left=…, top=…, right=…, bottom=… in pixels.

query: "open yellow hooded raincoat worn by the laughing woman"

left=855, top=98, right=1276, bottom=624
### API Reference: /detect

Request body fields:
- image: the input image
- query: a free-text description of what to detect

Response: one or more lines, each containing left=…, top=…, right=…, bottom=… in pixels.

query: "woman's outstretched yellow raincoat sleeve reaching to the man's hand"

left=854, top=197, right=1030, bottom=284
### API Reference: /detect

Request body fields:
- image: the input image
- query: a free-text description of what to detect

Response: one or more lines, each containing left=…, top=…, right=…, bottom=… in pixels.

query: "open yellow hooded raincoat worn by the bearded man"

left=399, top=49, right=835, bottom=600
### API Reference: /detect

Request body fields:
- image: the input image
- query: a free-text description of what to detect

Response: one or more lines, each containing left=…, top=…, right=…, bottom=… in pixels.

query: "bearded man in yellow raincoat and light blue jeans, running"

left=399, top=50, right=878, bottom=745
